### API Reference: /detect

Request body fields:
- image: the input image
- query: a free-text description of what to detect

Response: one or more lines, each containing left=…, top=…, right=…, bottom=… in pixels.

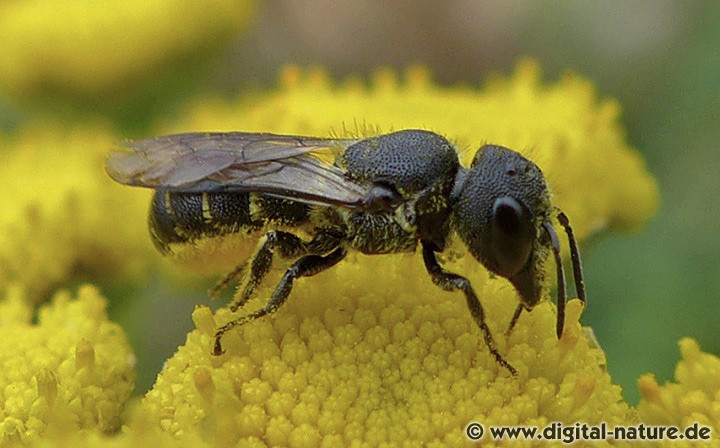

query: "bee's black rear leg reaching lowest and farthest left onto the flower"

left=213, top=246, right=347, bottom=356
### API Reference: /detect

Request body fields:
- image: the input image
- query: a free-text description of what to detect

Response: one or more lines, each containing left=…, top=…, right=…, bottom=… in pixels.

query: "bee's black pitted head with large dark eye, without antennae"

left=452, top=145, right=552, bottom=308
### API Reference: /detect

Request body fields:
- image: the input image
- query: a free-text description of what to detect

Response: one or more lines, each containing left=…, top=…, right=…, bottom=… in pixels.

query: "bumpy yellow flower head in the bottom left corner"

left=0, top=286, right=135, bottom=445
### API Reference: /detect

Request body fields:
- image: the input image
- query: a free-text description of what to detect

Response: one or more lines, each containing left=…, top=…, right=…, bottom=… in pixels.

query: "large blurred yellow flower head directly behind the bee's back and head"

left=174, top=60, right=659, bottom=243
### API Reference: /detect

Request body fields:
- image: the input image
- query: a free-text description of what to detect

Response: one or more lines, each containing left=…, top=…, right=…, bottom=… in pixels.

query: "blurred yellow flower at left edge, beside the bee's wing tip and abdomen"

left=0, top=122, right=155, bottom=301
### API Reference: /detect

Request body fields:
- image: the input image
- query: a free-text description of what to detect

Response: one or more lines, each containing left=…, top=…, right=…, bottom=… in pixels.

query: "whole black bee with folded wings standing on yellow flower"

left=107, top=130, right=585, bottom=375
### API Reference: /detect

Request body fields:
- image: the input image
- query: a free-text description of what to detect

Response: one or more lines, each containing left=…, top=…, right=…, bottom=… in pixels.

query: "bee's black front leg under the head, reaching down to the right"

left=423, top=244, right=517, bottom=376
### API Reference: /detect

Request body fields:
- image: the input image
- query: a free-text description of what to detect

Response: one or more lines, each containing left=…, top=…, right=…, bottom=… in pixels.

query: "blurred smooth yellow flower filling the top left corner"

left=0, top=0, right=255, bottom=100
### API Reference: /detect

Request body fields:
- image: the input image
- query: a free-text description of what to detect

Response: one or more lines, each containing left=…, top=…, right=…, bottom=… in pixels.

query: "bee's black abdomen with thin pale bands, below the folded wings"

left=149, top=190, right=309, bottom=254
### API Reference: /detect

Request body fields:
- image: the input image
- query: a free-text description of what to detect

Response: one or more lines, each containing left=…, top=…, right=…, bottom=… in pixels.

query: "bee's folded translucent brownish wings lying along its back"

left=106, top=132, right=371, bottom=208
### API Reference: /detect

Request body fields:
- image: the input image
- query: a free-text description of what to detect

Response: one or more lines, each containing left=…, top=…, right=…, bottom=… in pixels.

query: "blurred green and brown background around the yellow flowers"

left=0, top=0, right=720, bottom=403
